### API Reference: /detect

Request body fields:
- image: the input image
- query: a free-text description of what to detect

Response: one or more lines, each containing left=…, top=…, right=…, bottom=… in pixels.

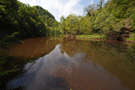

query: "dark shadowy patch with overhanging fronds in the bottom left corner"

left=0, top=56, right=32, bottom=90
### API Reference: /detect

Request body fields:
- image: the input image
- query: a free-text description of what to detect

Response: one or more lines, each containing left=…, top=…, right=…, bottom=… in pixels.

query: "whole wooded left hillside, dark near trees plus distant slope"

left=0, top=0, right=58, bottom=44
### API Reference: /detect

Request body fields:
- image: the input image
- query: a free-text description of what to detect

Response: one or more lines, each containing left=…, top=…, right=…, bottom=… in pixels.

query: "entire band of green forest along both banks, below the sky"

left=0, top=0, right=135, bottom=46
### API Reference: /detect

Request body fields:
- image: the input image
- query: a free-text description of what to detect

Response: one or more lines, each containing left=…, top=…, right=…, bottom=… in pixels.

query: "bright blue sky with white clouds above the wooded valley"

left=19, top=0, right=107, bottom=21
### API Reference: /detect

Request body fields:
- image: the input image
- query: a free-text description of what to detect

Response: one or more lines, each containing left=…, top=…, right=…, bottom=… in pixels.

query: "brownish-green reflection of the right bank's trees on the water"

left=61, top=39, right=135, bottom=90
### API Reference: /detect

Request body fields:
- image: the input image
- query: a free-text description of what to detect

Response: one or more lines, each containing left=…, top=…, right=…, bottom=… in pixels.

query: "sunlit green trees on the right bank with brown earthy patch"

left=60, top=0, right=135, bottom=40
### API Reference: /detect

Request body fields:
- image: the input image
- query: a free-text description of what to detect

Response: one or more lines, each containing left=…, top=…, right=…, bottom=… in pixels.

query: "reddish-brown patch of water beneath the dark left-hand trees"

left=1, top=37, right=59, bottom=58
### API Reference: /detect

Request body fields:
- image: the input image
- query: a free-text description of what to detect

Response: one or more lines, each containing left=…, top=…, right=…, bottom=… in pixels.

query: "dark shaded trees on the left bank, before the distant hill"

left=0, top=0, right=46, bottom=39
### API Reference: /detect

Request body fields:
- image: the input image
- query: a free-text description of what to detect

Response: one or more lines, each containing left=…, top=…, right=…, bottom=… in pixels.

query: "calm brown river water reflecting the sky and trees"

left=0, top=37, right=135, bottom=90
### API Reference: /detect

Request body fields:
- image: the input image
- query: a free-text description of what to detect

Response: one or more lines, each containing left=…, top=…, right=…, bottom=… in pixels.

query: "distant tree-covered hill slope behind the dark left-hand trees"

left=34, top=6, right=60, bottom=36
